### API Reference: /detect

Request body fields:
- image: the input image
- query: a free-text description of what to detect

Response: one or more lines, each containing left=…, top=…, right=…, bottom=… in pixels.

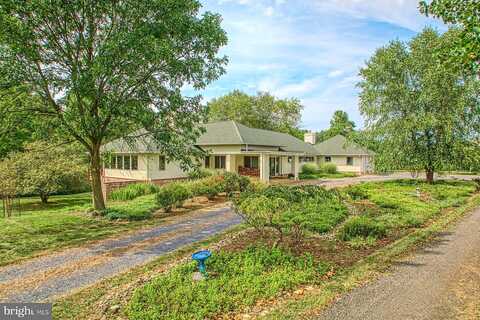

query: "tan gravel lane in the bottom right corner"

left=318, top=209, right=480, bottom=320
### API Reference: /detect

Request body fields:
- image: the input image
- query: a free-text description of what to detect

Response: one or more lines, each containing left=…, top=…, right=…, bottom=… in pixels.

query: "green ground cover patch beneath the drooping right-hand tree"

left=338, top=180, right=476, bottom=241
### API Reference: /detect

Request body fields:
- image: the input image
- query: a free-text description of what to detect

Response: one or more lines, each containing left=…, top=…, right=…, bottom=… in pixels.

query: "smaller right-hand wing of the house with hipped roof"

left=312, top=135, right=374, bottom=174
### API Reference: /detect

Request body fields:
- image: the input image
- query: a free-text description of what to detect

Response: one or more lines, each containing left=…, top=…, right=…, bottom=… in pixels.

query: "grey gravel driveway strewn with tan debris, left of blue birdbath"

left=0, top=204, right=241, bottom=302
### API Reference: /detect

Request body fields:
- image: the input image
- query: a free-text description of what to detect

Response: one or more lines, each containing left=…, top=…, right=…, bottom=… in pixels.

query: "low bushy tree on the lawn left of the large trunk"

left=8, top=141, right=87, bottom=203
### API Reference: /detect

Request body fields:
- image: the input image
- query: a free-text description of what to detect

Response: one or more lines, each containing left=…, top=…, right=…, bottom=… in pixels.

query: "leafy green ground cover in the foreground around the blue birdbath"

left=127, top=247, right=328, bottom=320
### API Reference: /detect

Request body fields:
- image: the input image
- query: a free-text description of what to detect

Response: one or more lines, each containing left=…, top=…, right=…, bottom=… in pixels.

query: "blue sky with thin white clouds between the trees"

left=191, top=0, right=445, bottom=131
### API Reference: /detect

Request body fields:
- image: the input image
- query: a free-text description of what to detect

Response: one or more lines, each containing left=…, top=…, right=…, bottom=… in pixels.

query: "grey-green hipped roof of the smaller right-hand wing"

left=314, top=135, right=373, bottom=156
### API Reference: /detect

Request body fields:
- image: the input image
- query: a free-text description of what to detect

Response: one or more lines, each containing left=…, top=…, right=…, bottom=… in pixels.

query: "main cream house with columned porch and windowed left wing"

left=102, top=121, right=317, bottom=184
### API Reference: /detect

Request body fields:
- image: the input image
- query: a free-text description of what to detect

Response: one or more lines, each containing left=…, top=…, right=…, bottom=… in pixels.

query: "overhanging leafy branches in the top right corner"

left=420, top=0, right=480, bottom=73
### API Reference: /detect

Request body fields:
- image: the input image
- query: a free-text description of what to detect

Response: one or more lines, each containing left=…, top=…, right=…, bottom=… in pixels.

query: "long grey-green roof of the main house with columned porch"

left=102, top=120, right=317, bottom=155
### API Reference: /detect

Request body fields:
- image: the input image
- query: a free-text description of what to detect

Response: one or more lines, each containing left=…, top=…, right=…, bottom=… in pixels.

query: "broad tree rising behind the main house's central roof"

left=208, top=90, right=303, bottom=139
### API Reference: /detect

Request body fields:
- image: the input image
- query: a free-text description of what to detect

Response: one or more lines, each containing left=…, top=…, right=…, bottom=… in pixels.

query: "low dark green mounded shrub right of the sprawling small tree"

left=338, top=216, right=387, bottom=241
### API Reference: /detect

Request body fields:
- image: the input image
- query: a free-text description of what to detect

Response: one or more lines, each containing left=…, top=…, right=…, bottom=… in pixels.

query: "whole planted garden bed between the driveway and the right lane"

left=123, top=180, right=475, bottom=319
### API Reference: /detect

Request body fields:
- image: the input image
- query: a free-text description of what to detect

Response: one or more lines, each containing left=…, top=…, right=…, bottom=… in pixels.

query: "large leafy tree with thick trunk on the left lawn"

left=0, top=0, right=227, bottom=210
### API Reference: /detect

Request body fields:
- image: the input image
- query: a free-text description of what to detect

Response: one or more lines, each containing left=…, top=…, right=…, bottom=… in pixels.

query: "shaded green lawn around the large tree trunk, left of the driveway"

left=0, top=193, right=158, bottom=265
